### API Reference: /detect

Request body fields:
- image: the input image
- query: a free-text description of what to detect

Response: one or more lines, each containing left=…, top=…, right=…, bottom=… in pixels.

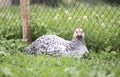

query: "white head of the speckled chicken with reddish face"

left=73, top=28, right=84, bottom=40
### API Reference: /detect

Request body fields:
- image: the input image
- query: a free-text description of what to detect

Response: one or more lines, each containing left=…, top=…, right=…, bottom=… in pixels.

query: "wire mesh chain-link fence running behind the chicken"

left=0, top=0, right=120, bottom=51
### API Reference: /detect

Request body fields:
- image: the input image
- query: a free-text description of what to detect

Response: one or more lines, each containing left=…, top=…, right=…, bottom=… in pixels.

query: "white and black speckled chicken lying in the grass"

left=25, top=28, right=88, bottom=56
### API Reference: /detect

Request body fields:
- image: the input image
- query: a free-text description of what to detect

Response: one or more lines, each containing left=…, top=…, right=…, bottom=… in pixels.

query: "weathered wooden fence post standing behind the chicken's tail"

left=20, top=0, right=31, bottom=43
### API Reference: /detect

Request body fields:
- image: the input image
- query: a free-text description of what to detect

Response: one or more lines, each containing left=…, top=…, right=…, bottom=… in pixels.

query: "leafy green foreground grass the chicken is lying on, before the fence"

left=0, top=40, right=120, bottom=77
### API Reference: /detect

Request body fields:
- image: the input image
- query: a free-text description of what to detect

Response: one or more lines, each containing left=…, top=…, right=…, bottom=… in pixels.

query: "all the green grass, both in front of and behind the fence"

left=0, top=0, right=120, bottom=77
